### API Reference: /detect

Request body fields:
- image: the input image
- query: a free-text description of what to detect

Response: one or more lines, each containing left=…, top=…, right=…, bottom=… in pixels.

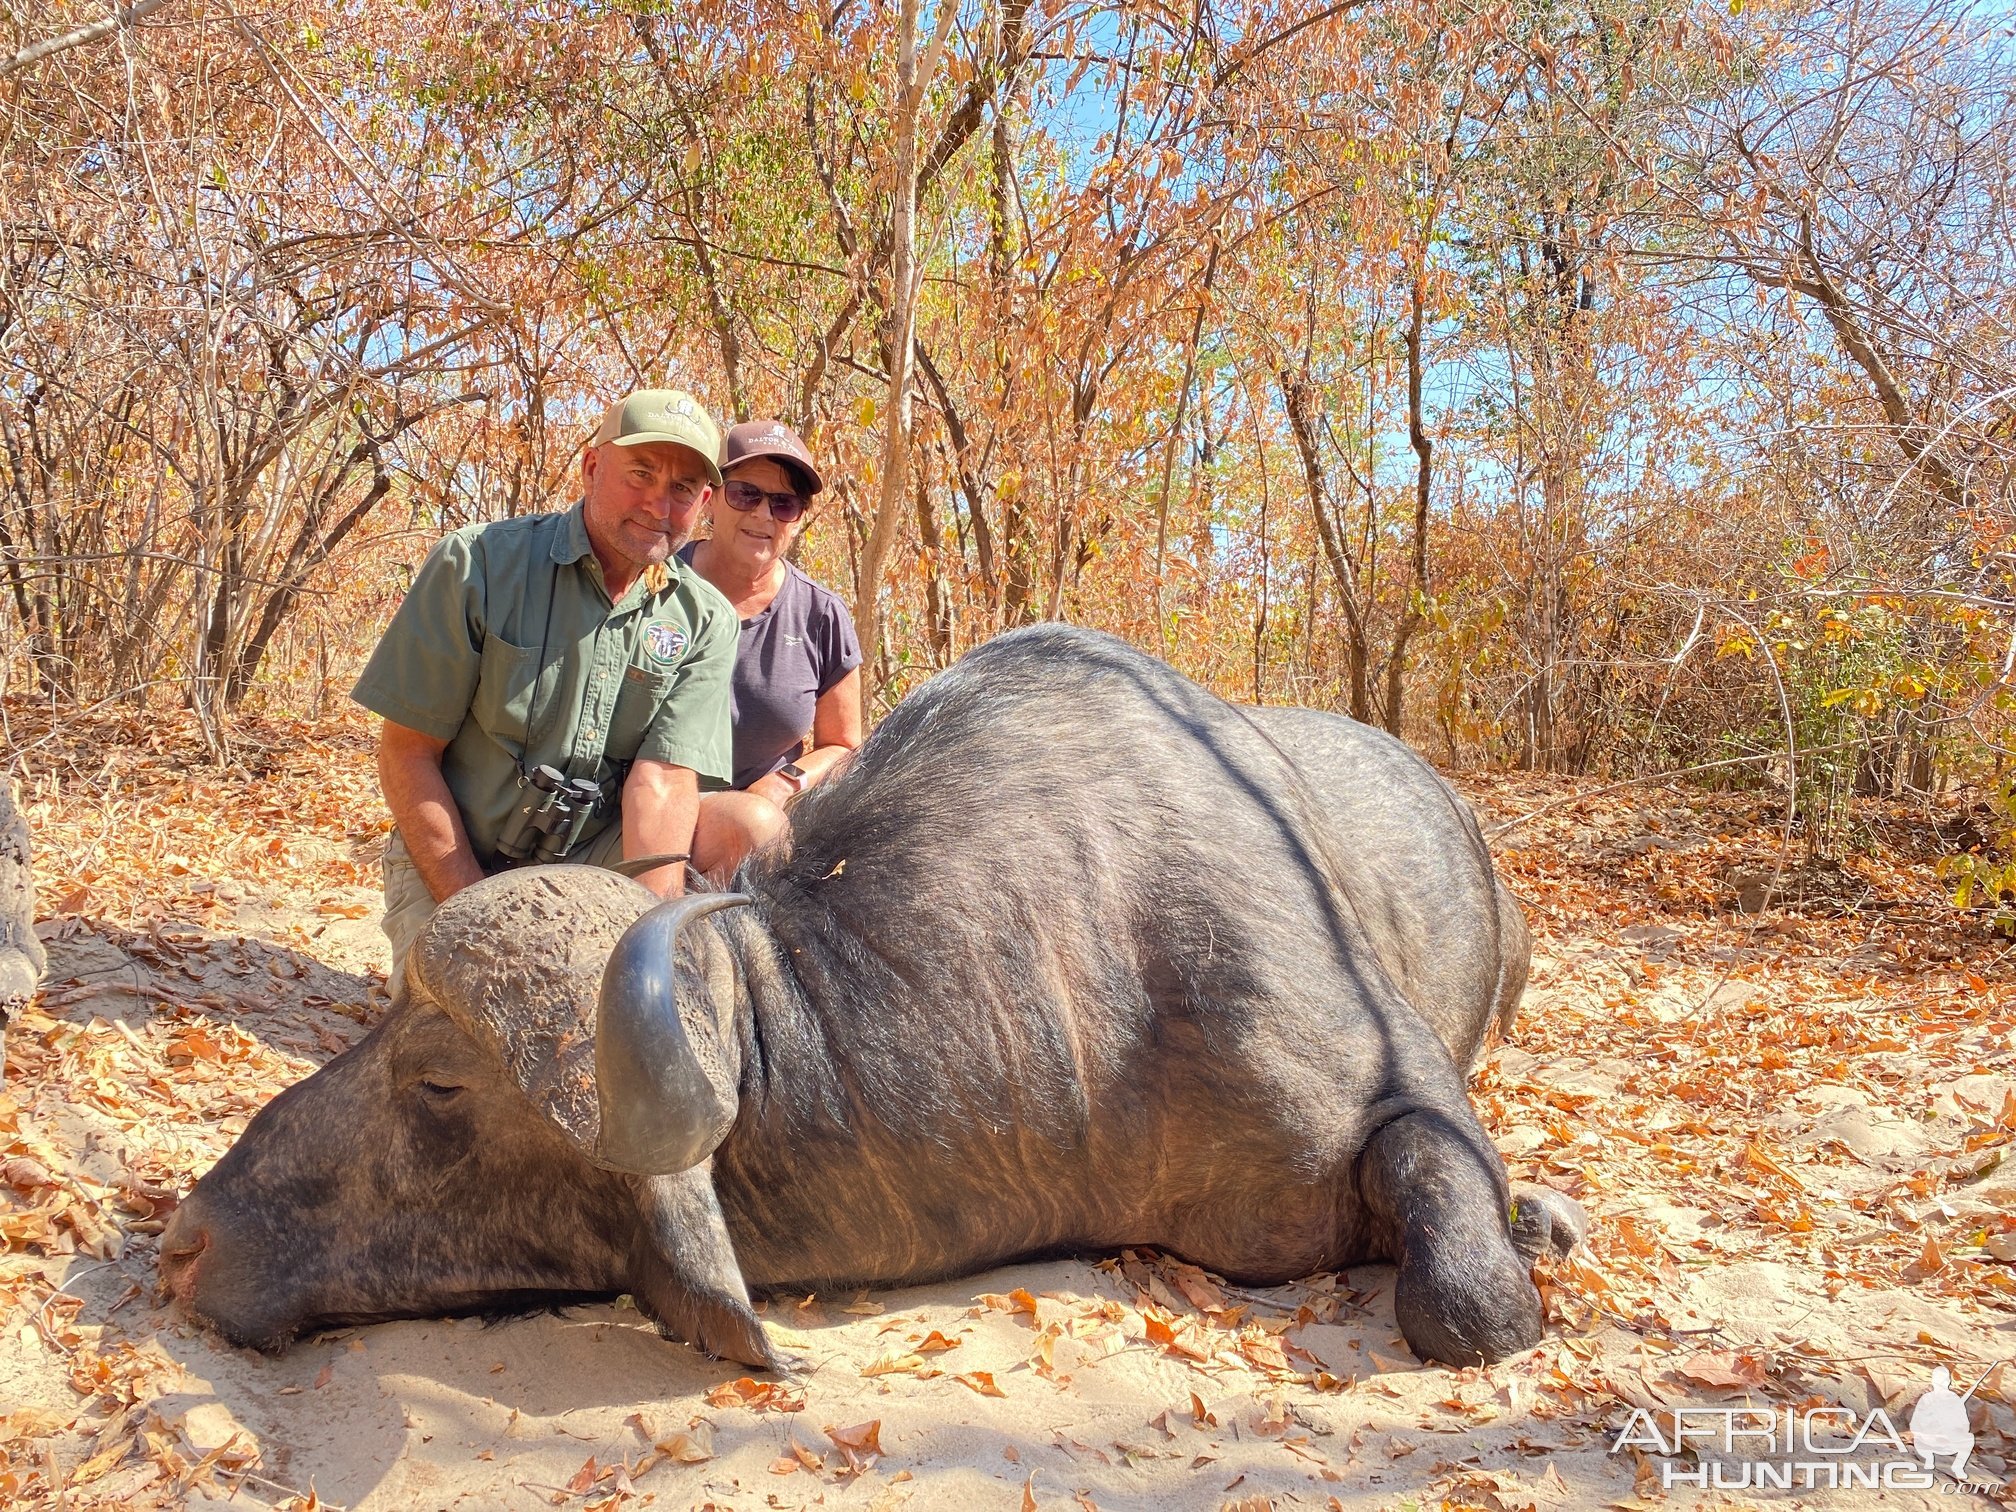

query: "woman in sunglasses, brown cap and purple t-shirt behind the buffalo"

left=679, top=419, right=861, bottom=881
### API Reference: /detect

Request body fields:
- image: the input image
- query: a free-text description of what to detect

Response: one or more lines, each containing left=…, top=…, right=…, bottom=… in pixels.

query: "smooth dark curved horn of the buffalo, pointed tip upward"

left=595, top=893, right=750, bottom=1175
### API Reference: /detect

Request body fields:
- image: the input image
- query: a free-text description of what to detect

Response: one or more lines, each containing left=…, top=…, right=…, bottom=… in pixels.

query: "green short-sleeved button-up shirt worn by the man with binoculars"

left=351, top=504, right=740, bottom=867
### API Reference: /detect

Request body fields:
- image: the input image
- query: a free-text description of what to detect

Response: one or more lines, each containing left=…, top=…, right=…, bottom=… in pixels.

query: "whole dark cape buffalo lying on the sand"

left=161, top=627, right=1579, bottom=1367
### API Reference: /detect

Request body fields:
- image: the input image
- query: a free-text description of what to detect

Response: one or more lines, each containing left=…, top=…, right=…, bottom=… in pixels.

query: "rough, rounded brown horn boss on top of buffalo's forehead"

left=405, top=867, right=657, bottom=1163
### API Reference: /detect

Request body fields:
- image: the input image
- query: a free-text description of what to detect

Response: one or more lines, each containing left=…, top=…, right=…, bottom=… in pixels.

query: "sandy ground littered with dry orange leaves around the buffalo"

left=0, top=770, right=2016, bottom=1512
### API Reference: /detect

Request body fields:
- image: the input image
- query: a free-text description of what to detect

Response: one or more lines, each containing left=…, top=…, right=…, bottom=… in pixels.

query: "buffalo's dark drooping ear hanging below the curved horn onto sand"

left=631, top=1161, right=788, bottom=1371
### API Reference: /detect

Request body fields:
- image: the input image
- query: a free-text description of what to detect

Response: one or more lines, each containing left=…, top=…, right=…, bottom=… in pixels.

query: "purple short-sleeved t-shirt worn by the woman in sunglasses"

left=679, top=542, right=861, bottom=788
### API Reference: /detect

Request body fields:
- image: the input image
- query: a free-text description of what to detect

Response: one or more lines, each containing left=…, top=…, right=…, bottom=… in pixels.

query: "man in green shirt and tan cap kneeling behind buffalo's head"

left=351, top=389, right=740, bottom=996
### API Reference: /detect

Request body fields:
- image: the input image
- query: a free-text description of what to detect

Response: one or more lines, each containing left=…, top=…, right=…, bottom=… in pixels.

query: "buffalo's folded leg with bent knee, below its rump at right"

left=1359, top=1109, right=1540, bottom=1365
